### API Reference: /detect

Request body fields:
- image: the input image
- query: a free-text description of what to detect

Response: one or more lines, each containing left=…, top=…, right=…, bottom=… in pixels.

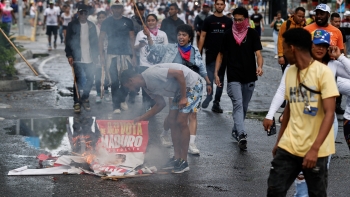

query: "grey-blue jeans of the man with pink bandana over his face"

left=227, top=81, right=255, bottom=136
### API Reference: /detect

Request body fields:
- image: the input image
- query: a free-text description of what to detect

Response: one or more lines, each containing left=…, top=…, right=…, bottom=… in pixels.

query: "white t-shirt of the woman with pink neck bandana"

left=135, top=30, right=168, bottom=67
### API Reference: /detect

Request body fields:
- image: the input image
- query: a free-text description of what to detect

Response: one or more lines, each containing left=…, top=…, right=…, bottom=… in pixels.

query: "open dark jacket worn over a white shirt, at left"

left=65, top=19, right=99, bottom=61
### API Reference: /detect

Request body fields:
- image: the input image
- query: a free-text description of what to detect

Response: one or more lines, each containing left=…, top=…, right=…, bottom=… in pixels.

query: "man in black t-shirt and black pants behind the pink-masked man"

left=197, top=0, right=232, bottom=113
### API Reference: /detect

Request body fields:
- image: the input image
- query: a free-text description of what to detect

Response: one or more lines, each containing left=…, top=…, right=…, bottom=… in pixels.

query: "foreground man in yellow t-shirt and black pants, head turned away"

left=267, top=28, right=339, bottom=197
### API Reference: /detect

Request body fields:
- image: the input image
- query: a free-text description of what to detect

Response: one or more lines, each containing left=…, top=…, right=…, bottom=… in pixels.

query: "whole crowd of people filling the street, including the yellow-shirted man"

left=4, top=0, right=350, bottom=196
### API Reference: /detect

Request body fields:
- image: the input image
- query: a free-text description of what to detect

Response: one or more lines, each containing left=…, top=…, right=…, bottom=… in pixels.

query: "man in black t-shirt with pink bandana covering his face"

left=214, top=7, right=263, bottom=150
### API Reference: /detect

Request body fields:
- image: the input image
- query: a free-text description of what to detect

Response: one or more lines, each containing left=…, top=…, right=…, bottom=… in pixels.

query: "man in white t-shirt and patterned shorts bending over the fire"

left=121, top=63, right=211, bottom=173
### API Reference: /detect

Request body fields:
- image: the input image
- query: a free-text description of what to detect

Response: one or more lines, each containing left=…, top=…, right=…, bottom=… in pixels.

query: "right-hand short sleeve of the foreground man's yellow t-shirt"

left=320, top=67, right=339, bottom=99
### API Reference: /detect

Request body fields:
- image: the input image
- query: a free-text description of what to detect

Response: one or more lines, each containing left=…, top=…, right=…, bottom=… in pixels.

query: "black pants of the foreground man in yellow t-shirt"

left=267, top=148, right=328, bottom=197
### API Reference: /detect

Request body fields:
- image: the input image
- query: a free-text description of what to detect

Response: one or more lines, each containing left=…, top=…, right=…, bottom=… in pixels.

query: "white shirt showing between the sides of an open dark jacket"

left=80, top=22, right=92, bottom=64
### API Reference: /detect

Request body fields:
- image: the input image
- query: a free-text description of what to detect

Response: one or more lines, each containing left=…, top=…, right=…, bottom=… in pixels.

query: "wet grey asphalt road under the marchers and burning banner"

left=0, top=42, right=350, bottom=197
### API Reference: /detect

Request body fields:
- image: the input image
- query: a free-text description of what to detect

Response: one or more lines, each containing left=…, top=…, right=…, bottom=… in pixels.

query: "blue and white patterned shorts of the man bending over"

left=170, top=79, right=203, bottom=113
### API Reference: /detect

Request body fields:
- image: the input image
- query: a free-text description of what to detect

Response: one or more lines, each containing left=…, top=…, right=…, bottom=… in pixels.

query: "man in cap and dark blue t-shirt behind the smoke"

left=99, top=0, right=136, bottom=114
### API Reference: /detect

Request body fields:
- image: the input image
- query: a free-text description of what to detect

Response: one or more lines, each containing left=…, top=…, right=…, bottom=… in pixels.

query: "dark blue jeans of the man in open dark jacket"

left=73, top=63, right=95, bottom=104
